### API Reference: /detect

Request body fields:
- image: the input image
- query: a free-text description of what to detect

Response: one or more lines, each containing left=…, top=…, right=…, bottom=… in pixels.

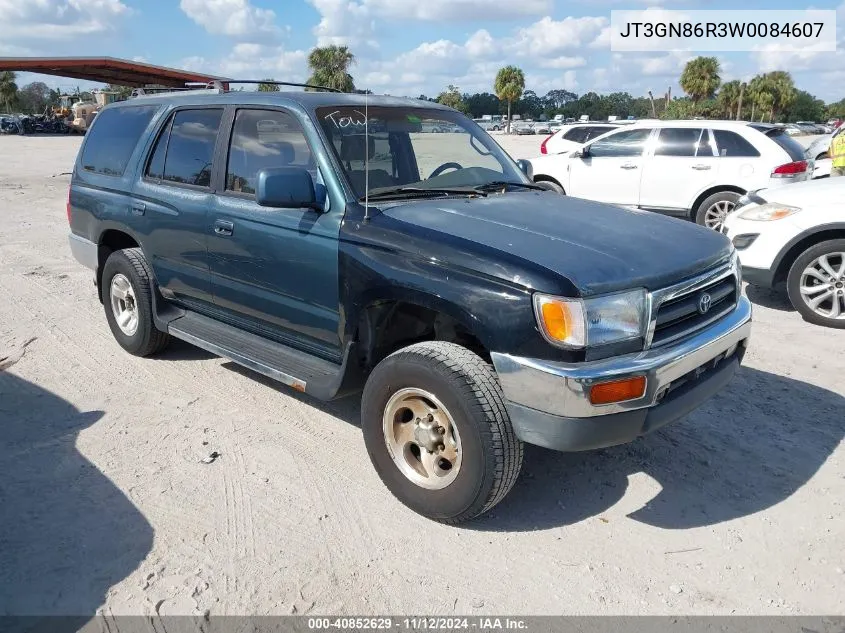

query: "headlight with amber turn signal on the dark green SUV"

left=534, top=288, right=647, bottom=348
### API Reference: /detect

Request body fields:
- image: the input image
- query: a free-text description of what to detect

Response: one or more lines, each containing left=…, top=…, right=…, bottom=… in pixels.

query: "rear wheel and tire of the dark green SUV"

left=101, top=248, right=170, bottom=356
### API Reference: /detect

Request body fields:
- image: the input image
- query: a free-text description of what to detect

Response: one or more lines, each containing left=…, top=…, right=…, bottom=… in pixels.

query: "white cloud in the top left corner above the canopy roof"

left=0, top=0, right=132, bottom=41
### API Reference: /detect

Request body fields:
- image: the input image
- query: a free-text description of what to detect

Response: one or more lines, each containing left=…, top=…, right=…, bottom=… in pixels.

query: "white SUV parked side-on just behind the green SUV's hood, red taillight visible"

left=530, top=121, right=813, bottom=230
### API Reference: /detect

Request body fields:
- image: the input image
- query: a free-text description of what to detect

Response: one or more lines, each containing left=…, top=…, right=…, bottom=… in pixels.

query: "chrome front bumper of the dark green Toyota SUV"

left=492, top=297, right=751, bottom=451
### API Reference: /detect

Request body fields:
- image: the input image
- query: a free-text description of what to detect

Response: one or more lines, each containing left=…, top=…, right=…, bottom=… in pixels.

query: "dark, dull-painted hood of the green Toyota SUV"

left=383, top=192, right=731, bottom=296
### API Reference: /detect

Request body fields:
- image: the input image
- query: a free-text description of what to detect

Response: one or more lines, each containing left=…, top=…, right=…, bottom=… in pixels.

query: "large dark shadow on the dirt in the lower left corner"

left=0, top=372, right=153, bottom=616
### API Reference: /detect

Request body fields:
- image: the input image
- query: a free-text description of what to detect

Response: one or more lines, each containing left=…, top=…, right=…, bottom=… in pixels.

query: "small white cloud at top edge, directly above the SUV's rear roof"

left=179, top=0, right=279, bottom=40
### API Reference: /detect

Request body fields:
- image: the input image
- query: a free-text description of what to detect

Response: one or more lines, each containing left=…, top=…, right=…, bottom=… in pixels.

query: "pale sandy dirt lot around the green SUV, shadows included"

left=0, top=137, right=845, bottom=614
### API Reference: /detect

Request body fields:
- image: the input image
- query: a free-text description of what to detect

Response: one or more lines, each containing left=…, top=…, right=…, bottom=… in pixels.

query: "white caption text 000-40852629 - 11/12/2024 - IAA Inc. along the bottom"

left=308, top=616, right=528, bottom=631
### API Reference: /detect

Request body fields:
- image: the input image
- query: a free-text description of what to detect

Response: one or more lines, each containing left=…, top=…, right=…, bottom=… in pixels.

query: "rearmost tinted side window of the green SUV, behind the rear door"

left=81, top=106, right=158, bottom=177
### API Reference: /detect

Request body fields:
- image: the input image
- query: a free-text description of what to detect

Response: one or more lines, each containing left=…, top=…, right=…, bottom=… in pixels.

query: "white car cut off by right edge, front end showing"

left=724, top=178, right=845, bottom=329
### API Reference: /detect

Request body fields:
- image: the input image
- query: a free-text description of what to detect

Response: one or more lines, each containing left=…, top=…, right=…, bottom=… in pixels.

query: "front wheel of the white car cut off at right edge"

left=786, top=239, right=845, bottom=329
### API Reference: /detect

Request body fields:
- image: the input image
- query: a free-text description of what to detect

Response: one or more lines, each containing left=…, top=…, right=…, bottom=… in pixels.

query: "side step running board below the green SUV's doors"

left=167, top=312, right=346, bottom=400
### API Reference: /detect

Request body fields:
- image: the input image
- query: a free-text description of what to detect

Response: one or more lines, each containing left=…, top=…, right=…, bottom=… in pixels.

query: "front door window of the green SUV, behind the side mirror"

left=226, top=110, right=316, bottom=194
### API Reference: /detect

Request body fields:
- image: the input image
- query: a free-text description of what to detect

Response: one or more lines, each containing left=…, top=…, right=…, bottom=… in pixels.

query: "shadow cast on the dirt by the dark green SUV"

left=225, top=363, right=845, bottom=532
